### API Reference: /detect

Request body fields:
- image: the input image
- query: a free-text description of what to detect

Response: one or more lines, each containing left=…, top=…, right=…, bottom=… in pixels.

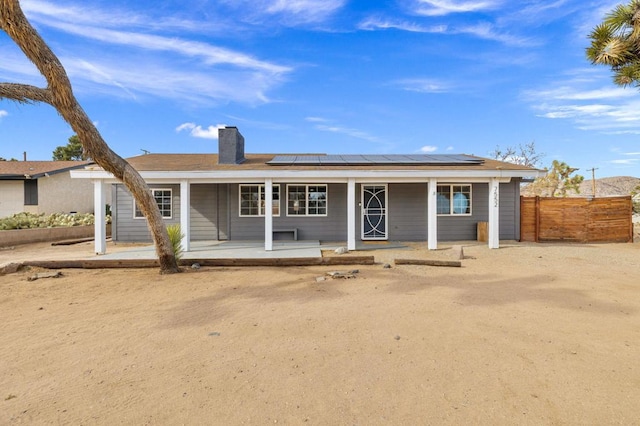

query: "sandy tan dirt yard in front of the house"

left=0, top=243, right=640, bottom=425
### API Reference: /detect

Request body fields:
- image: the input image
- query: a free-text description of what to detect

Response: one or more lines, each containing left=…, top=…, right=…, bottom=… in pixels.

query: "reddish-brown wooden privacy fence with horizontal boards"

left=520, top=196, right=633, bottom=243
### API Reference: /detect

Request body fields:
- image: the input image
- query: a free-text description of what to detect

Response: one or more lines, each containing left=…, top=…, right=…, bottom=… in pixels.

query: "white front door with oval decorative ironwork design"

left=362, top=185, right=387, bottom=240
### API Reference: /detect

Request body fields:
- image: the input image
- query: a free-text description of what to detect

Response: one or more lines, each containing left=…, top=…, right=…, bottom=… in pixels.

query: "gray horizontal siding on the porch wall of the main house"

left=112, top=180, right=520, bottom=242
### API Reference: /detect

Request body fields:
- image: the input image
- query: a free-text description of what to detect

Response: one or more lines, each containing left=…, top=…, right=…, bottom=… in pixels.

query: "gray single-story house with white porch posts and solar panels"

left=72, top=127, right=544, bottom=253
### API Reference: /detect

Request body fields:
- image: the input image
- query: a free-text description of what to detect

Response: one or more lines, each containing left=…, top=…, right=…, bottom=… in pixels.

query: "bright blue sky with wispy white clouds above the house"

left=0, top=0, right=640, bottom=177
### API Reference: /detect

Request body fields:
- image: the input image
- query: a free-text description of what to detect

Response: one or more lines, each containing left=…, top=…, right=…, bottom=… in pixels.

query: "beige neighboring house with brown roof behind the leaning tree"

left=0, top=161, right=94, bottom=217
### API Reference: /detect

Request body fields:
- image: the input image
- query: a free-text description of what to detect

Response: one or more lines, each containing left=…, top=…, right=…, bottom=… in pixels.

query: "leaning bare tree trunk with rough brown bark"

left=0, top=0, right=179, bottom=273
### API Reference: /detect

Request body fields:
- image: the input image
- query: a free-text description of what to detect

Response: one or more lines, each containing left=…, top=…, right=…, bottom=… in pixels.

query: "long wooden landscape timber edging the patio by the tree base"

left=22, top=256, right=374, bottom=269
